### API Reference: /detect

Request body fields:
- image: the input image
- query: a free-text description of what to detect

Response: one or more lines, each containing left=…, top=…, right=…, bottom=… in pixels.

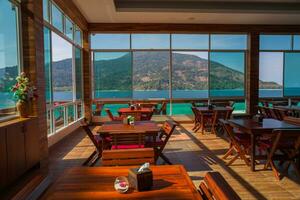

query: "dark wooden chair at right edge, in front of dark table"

left=264, top=129, right=300, bottom=180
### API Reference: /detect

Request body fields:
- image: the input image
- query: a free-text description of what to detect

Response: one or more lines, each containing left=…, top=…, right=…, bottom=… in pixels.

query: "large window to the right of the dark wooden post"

left=259, top=35, right=300, bottom=97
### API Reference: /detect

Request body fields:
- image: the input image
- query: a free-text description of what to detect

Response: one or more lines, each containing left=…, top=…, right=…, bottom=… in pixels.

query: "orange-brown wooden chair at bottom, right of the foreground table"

left=199, top=172, right=241, bottom=200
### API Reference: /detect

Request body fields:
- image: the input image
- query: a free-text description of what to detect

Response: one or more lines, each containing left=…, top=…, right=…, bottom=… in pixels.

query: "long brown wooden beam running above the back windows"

left=89, top=23, right=300, bottom=33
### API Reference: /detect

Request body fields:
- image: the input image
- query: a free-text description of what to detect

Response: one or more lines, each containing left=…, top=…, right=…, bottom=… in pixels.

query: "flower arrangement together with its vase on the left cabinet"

left=11, top=72, right=37, bottom=117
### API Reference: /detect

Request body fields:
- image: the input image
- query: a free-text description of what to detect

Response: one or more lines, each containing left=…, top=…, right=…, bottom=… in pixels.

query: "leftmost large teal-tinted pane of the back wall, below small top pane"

left=94, top=52, right=132, bottom=98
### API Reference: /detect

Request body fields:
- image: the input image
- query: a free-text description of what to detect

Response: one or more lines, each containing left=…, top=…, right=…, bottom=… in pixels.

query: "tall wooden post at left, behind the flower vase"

left=21, top=0, right=48, bottom=170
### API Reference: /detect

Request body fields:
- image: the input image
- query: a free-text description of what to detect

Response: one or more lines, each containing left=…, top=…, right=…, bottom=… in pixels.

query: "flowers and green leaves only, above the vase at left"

left=11, top=72, right=37, bottom=102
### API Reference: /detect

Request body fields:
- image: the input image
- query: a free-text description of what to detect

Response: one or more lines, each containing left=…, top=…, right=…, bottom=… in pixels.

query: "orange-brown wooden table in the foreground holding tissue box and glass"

left=42, top=165, right=202, bottom=200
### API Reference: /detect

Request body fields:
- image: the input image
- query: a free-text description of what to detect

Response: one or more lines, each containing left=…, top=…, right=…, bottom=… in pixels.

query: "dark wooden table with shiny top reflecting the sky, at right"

left=228, top=119, right=300, bottom=171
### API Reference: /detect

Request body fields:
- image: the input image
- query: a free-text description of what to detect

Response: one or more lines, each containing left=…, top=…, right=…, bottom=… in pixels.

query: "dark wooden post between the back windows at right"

left=246, top=32, right=259, bottom=115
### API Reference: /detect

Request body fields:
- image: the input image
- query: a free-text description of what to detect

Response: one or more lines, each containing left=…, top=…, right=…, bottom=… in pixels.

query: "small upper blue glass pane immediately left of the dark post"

left=210, top=34, right=247, bottom=50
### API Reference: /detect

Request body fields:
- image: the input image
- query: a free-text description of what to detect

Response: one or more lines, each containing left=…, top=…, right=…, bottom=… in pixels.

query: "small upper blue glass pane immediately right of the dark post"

left=259, top=35, right=292, bottom=50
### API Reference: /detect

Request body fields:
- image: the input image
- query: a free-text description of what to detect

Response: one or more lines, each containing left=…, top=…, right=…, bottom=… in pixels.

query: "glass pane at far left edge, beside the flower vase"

left=0, top=0, right=19, bottom=112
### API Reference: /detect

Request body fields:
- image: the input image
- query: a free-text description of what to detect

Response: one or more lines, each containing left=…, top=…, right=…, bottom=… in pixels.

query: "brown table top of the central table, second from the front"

left=97, top=121, right=160, bottom=134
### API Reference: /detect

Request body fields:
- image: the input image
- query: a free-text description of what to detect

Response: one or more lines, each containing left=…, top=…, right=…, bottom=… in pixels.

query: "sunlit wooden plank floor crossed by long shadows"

left=50, top=119, right=300, bottom=200
